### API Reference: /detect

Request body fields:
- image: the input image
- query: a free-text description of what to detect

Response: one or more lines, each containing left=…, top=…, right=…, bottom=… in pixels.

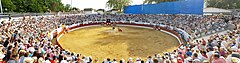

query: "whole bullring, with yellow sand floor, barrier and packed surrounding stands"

left=0, top=14, right=240, bottom=63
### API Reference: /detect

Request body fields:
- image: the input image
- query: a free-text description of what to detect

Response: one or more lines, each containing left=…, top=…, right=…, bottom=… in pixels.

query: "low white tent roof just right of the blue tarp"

left=203, top=8, right=232, bottom=13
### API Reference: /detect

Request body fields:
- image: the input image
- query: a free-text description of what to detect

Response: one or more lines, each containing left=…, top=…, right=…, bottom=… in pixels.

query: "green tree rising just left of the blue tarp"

left=106, top=0, right=132, bottom=11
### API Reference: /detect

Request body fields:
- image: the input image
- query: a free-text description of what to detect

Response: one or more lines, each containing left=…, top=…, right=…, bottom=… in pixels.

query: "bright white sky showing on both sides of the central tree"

left=62, top=0, right=143, bottom=10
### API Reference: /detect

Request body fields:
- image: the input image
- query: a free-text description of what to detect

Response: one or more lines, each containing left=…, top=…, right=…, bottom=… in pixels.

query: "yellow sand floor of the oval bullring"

left=59, top=26, right=179, bottom=60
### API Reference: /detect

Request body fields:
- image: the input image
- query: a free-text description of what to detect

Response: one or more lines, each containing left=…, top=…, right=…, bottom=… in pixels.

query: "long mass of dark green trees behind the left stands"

left=2, top=0, right=70, bottom=13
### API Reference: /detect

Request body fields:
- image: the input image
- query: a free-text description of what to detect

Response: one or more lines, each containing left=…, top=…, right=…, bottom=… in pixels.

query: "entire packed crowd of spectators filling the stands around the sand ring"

left=0, top=14, right=240, bottom=63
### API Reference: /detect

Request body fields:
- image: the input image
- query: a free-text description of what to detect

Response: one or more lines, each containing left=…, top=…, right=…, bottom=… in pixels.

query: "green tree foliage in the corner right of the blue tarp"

left=207, top=0, right=240, bottom=9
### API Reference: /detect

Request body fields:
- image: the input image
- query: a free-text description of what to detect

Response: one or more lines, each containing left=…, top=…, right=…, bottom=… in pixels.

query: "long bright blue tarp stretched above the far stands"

left=124, top=0, right=204, bottom=14
